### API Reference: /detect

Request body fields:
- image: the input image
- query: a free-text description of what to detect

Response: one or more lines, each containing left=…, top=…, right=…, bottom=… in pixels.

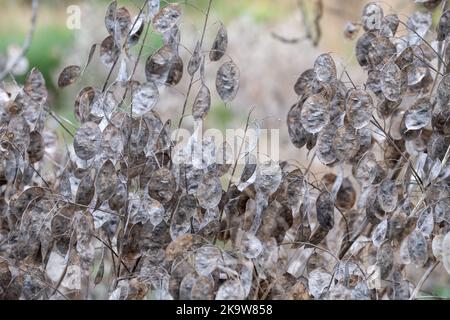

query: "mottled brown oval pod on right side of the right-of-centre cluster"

left=345, top=90, right=373, bottom=129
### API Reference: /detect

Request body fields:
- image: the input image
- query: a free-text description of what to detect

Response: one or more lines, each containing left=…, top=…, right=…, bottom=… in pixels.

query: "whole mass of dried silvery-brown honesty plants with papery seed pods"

left=0, top=0, right=450, bottom=300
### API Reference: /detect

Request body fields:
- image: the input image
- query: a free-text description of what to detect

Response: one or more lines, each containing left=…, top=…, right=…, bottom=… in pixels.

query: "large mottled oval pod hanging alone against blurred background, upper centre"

left=216, top=61, right=240, bottom=103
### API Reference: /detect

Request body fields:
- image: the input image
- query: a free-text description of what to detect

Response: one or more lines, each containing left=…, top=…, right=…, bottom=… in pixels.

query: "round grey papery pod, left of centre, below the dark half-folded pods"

left=73, top=122, right=102, bottom=160
